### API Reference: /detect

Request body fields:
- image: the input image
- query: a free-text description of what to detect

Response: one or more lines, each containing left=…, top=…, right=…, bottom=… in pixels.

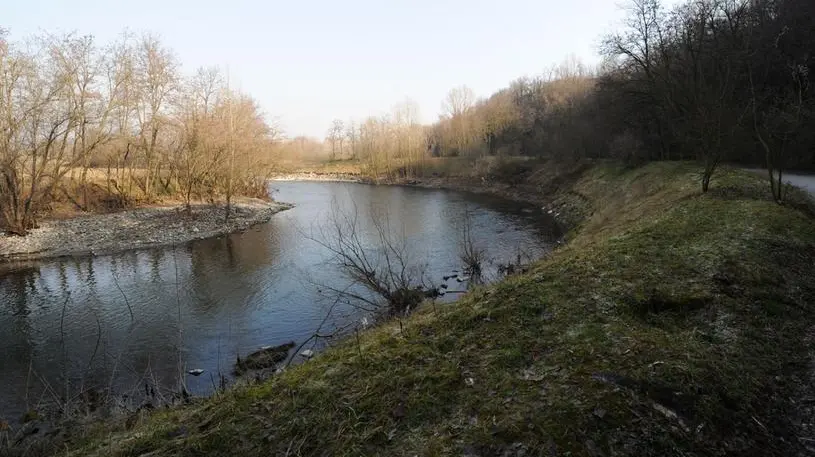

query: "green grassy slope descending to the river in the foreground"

left=73, top=164, right=815, bottom=457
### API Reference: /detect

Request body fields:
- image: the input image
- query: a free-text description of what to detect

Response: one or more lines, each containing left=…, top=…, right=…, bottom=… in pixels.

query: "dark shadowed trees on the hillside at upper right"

left=596, top=0, right=815, bottom=193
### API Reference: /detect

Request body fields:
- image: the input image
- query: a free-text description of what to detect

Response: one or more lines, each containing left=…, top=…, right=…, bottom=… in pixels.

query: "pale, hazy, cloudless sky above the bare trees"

left=0, top=0, right=684, bottom=138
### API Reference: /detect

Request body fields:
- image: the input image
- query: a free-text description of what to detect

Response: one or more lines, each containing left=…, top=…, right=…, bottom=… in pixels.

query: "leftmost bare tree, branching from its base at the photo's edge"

left=0, top=30, right=95, bottom=235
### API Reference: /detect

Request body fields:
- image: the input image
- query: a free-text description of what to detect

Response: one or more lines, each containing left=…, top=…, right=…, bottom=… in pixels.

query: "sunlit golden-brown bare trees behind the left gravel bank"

left=0, top=31, right=275, bottom=234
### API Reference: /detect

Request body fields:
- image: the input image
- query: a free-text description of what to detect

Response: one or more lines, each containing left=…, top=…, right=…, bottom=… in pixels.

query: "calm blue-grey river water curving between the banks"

left=0, top=182, right=561, bottom=420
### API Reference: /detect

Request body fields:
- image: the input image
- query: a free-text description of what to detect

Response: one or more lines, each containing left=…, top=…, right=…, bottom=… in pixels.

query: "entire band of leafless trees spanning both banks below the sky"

left=0, top=0, right=815, bottom=234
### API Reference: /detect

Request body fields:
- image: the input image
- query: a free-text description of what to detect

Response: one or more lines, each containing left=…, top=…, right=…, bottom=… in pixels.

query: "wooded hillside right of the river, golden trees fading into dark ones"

left=330, top=0, right=815, bottom=194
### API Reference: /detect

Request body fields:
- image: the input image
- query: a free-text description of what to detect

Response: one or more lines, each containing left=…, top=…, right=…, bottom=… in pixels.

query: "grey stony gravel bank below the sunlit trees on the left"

left=0, top=198, right=291, bottom=264
